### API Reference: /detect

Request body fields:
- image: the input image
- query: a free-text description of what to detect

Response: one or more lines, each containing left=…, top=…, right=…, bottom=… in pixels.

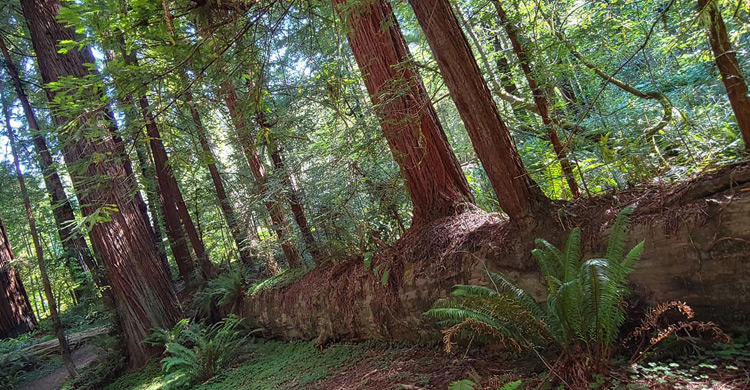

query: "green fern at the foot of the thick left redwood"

left=155, top=315, right=252, bottom=388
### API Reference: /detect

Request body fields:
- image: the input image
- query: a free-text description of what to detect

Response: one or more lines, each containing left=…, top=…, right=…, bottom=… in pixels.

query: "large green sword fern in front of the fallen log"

left=426, top=209, right=643, bottom=365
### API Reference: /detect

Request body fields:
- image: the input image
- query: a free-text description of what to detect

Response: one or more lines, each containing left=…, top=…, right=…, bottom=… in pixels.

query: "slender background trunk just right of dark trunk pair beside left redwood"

left=183, top=90, right=255, bottom=269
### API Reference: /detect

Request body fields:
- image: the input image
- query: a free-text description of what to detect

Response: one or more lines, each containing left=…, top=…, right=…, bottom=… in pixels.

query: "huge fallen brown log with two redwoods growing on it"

left=241, top=163, right=750, bottom=345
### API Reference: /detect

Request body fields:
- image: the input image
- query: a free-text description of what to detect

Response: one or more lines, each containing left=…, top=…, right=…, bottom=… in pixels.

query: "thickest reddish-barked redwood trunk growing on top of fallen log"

left=333, top=0, right=473, bottom=226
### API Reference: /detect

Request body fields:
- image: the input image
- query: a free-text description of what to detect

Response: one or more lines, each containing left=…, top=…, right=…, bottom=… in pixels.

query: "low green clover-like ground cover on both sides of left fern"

left=105, top=341, right=370, bottom=390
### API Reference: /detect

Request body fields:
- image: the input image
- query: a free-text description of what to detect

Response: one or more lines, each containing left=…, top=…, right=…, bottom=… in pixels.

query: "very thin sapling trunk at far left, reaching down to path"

left=0, top=90, right=78, bottom=378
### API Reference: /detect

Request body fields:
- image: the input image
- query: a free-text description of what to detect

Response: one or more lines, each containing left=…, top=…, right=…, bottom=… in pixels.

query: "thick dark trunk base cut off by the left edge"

left=0, top=216, right=37, bottom=339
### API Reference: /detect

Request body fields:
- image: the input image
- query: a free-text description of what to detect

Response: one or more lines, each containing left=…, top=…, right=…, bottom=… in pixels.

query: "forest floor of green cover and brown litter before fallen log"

left=95, top=341, right=750, bottom=390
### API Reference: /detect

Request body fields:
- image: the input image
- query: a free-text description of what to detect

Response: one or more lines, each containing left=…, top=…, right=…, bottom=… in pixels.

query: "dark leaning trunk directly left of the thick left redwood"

left=0, top=38, right=114, bottom=309
